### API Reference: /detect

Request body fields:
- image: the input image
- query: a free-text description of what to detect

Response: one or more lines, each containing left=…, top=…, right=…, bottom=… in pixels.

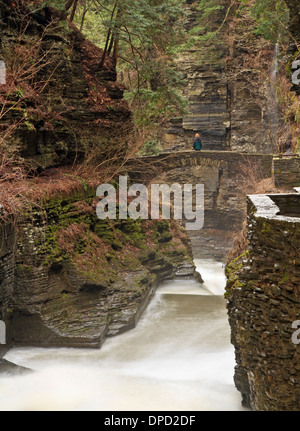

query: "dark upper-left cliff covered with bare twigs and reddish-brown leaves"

left=0, top=0, right=131, bottom=167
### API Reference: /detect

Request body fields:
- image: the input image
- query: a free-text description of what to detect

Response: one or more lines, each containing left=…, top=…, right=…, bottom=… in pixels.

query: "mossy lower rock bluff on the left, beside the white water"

left=0, top=192, right=195, bottom=354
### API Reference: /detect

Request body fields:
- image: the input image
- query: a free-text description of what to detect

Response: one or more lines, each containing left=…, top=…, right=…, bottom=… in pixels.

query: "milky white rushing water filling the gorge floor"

left=0, top=261, right=242, bottom=411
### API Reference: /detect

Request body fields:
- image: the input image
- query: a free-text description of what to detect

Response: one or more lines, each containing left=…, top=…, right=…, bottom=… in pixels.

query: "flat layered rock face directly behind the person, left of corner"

left=166, top=2, right=230, bottom=150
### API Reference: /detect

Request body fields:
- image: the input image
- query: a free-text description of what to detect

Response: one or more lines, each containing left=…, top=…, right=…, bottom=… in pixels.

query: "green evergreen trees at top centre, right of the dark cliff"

left=75, top=0, right=186, bottom=142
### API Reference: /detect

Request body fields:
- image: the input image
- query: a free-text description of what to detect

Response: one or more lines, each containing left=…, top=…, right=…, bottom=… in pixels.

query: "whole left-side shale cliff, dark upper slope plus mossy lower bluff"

left=0, top=0, right=195, bottom=355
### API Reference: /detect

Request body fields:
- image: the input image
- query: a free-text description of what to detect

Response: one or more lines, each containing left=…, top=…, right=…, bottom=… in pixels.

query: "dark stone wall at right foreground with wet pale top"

left=226, top=195, right=300, bottom=411
